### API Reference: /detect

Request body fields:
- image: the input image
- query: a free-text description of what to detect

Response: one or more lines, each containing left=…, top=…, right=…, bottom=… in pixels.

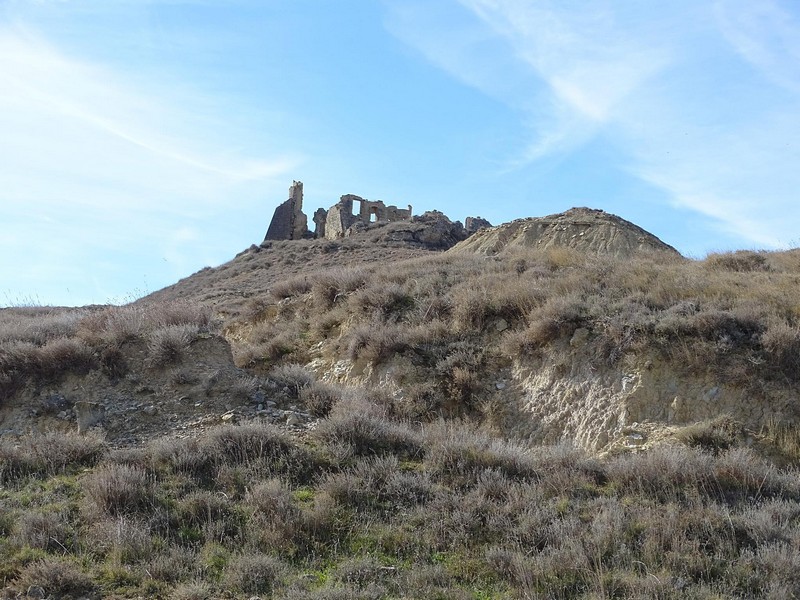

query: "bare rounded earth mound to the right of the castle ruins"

left=452, top=208, right=678, bottom=257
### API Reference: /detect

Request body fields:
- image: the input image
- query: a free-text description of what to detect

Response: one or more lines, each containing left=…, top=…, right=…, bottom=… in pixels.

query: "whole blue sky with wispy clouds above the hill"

left=0, top=0, right=800, bottom=305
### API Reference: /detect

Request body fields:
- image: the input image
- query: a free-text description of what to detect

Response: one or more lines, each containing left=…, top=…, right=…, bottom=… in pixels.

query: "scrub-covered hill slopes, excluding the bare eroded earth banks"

left=0, top=233, right=800, bottom=598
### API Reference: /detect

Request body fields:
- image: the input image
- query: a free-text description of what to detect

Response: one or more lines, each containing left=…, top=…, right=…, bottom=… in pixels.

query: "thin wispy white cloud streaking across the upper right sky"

left=392, top=0, right=800, bottom=246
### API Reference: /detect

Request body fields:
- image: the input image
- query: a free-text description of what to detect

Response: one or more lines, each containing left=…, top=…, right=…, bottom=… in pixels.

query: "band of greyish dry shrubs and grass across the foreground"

left=0, top=414, right=800, bottom=599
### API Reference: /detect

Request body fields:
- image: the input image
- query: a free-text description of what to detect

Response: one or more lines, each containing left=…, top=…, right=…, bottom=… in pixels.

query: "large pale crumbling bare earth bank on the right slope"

left=514, top=349, right=796, bottom=451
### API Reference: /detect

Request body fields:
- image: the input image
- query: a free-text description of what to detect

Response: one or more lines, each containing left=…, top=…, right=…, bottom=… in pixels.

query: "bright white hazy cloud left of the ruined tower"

left=0, top=24, right=302, bottom=303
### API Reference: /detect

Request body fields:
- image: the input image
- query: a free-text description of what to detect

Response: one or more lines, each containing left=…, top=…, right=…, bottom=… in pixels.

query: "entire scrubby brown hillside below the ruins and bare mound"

left=0, top=210, right=800, bottom=600
